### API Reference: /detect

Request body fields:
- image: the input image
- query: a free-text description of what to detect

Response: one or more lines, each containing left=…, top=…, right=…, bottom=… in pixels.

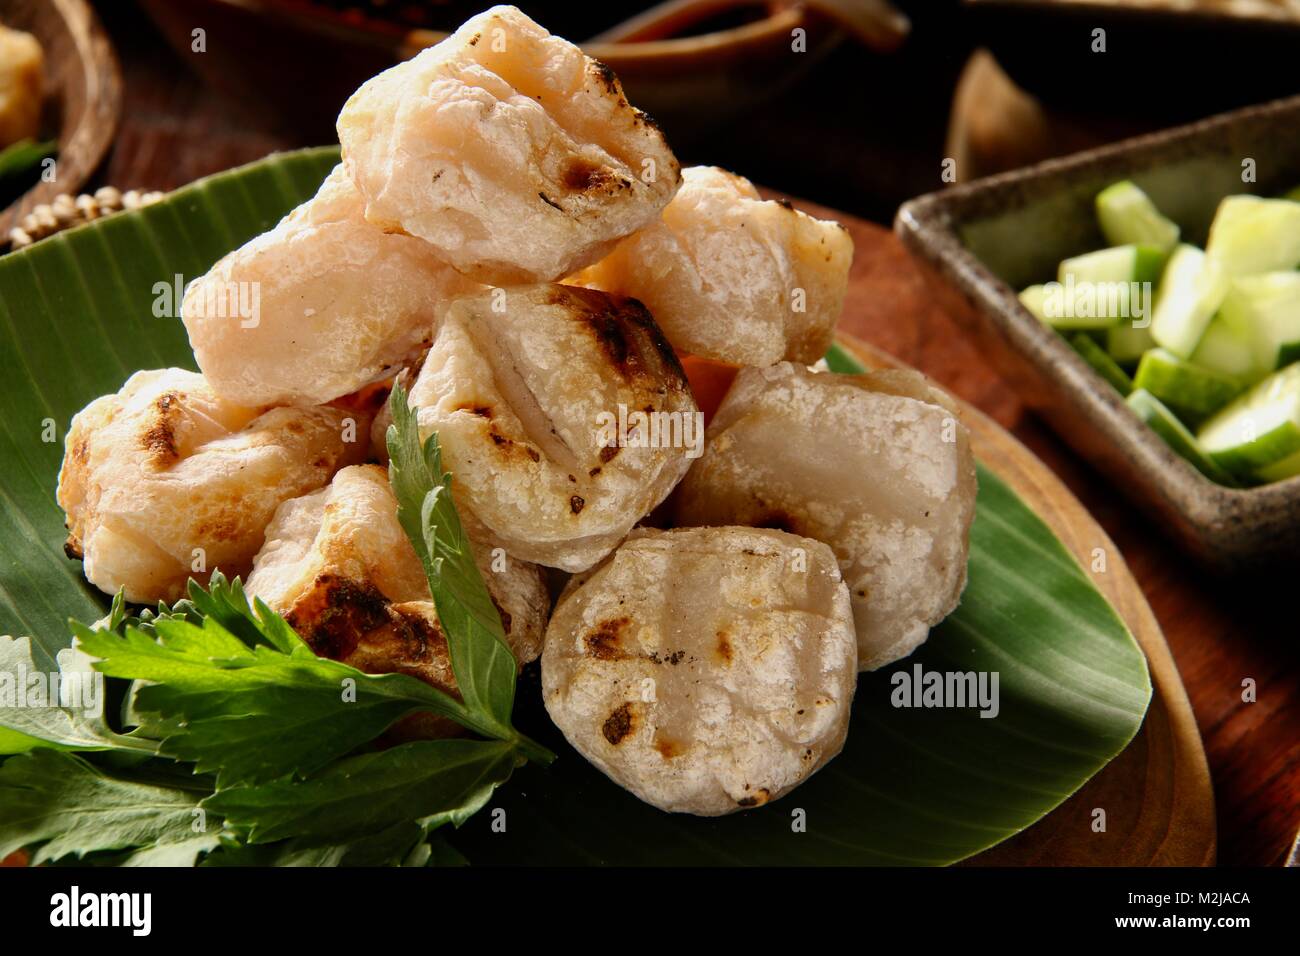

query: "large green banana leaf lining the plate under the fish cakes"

left=0, top=148, right=1151, bottom=865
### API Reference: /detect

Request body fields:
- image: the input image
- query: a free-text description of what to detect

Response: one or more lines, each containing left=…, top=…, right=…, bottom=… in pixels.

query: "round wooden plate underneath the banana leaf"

left=839, top=333, right=1216, bottom=866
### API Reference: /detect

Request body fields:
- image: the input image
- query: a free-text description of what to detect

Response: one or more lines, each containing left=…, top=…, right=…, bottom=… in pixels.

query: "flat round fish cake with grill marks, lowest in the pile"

left=542, top=528, right=858, bottom=816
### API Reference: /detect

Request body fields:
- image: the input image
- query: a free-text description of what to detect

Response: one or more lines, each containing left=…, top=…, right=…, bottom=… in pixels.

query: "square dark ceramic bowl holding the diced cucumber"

left=894, top=98, right=1300, bottom=571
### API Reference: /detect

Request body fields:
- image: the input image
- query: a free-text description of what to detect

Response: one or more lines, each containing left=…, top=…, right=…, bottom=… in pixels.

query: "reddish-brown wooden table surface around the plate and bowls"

left=81, top=4, right=1300, bottom=865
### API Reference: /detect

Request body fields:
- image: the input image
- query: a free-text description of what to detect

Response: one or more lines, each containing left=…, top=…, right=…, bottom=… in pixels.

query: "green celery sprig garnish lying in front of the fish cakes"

left=0, top=386, right=554, bottom=865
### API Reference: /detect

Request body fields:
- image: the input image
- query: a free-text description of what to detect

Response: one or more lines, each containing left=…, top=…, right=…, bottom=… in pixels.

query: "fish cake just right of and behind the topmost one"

left=569, top=166, right=853, bottom=367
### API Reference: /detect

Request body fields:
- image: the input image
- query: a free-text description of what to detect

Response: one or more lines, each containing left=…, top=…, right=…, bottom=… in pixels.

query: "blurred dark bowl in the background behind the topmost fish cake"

left=140, top=0, right=907, bottom=142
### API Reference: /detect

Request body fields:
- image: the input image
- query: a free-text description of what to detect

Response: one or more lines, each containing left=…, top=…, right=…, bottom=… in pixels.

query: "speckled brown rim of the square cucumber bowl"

left=894, top=96, right=1300, bottom=546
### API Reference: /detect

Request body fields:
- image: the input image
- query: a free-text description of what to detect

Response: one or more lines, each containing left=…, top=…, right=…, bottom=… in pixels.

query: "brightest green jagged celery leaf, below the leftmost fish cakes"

left=78, top=609, right=478, bottom=787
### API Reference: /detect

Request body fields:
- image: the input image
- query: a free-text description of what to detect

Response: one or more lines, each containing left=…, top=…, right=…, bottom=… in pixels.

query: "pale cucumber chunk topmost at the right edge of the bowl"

left=1205, top=195, right=1300, bottom=277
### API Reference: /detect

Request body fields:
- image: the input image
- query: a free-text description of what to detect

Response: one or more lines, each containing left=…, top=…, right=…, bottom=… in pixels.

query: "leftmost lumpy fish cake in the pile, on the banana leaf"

left=57, top=368, right=371, bottom=604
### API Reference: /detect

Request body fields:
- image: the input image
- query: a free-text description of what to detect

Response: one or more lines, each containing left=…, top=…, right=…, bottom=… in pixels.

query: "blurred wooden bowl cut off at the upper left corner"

left=0, top=0, right=122, bottom=235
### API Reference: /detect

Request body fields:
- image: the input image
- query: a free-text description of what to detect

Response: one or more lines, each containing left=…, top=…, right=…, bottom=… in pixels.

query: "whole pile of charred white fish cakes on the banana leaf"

left=59, top=7, right=974, bottom=814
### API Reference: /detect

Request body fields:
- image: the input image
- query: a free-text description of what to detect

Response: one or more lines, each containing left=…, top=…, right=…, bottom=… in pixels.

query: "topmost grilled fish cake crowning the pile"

left=338, top=7, right=681, bottom=285
